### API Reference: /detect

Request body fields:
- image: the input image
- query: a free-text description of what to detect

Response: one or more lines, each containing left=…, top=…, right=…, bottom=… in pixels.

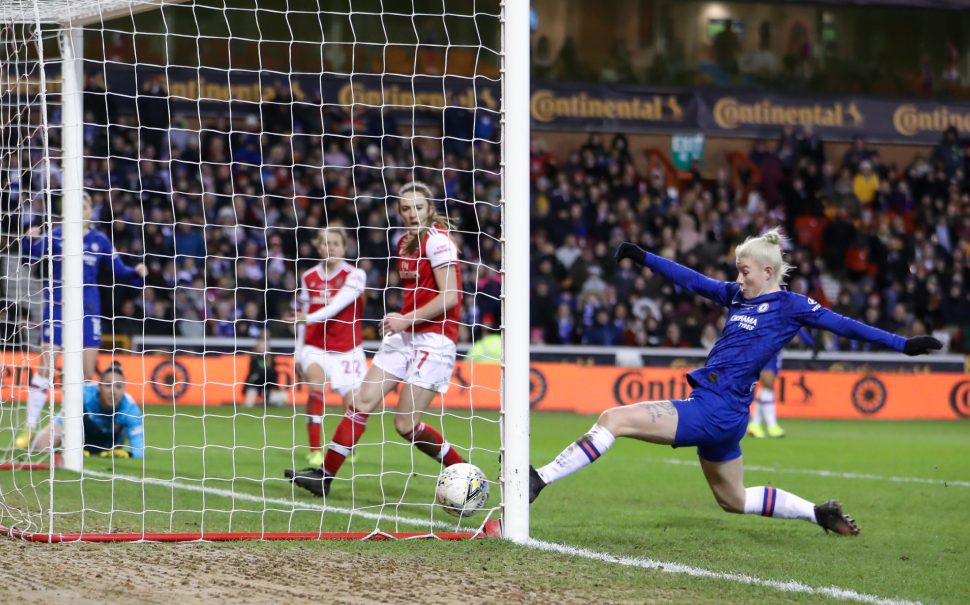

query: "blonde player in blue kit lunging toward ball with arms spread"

left=529, top=230, right=942, bottom=535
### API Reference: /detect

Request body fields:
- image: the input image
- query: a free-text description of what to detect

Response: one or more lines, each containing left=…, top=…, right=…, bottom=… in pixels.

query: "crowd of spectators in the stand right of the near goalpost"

left=531, top=128, right=970, bottom=351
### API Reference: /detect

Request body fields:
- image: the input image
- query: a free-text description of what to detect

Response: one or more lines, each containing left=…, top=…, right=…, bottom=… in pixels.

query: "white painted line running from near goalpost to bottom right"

left=521, top=539, right=920, bottom=605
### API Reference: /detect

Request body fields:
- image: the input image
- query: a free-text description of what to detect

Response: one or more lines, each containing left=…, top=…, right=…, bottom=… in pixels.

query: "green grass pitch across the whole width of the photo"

left=0, top=407, right=970, bottom=603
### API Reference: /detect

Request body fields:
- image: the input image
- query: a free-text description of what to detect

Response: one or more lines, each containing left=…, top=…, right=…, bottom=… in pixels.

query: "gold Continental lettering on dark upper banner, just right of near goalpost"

left=530, top=89, right=685, bottom=122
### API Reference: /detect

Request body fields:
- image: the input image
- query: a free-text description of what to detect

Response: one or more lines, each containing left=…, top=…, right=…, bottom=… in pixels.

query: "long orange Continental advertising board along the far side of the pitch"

left=0, top=353, right=970, bottom=420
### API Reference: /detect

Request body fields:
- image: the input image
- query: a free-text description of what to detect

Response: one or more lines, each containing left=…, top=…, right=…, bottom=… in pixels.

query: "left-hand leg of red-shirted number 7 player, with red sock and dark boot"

left=284, top=364, right=401, bottom=496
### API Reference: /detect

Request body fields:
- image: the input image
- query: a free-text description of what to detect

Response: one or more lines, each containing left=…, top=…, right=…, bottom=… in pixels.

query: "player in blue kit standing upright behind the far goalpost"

left=14, top=192, right=148, bottom=448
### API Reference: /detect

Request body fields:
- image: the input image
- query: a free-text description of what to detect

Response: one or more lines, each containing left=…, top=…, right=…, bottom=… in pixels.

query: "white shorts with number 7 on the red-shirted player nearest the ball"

left=374, top=332, right=458, bottom=393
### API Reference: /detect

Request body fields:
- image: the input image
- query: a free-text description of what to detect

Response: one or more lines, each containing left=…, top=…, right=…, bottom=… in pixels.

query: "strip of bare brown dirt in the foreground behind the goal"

left=0, top=539, right=588, bottom=605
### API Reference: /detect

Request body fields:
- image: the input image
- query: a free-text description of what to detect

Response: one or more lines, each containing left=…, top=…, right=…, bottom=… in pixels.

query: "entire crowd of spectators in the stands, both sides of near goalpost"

left=56, top=76, right=970, bottom=351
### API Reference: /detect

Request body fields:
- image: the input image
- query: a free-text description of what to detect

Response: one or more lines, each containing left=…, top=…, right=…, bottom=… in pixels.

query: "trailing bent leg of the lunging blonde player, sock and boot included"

left=700, top=456, right=859, bottom=535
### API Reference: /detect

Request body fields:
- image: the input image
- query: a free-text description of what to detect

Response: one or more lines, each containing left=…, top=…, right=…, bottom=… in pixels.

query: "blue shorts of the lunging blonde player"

left=672, top=389, right=750, bottom=462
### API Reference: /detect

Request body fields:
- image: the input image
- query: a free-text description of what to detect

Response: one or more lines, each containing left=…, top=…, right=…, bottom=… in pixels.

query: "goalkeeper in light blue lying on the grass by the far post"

left=30, top=363, right=145, bottom=459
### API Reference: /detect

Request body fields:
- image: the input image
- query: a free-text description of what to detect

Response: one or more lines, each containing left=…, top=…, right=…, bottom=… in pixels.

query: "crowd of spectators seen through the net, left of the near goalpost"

left=75, top=82, right=501, bottom=340
